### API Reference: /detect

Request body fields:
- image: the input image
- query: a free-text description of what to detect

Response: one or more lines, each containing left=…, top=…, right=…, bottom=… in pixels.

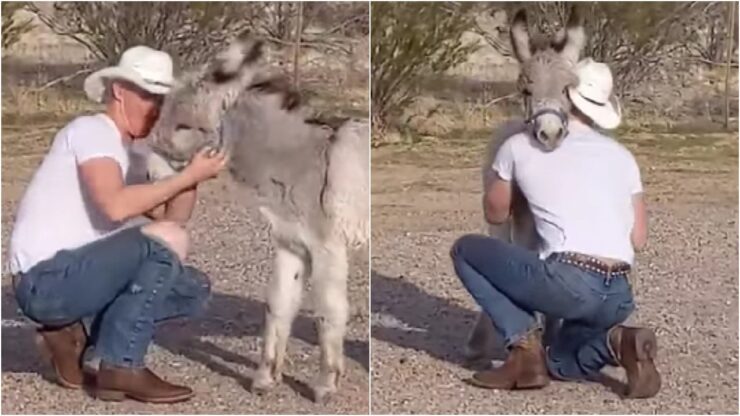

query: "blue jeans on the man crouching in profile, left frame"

left=15, top=227, right=211, bottom=367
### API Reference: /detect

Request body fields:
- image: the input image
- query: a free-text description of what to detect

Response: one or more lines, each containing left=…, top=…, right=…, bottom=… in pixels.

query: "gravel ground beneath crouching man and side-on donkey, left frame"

left=2, top=159, right=369, bottom=414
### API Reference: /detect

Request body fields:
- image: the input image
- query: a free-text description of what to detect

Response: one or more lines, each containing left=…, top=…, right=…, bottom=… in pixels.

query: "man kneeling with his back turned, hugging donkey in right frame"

left=451, top=59, right=661, bottom=398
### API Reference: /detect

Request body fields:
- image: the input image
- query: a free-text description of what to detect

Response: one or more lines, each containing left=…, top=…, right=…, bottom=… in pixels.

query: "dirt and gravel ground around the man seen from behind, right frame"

left=371, top=132, right=738, bottom=414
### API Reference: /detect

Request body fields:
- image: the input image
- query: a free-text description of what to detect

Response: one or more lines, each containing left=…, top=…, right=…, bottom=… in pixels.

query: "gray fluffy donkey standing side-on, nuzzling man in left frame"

left=148, top=40, right=370, bottom=401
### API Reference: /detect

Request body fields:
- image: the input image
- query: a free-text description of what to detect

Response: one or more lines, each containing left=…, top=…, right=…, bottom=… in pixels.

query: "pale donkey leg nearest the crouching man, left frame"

left=252, top=243, right=306, bottom=392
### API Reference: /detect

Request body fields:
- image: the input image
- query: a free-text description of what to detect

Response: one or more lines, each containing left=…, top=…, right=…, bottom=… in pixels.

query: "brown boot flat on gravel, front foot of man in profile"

left=93, top=363, right=194, bottom=403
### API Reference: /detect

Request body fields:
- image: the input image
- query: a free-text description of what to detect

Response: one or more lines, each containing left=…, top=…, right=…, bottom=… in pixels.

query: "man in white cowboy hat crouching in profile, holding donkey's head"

left=10, top=46, right=226, bottom=403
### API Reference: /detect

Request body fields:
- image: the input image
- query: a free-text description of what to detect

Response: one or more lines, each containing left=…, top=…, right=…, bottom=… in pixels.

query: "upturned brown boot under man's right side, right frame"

left=609, top=325, right=661, bottom=399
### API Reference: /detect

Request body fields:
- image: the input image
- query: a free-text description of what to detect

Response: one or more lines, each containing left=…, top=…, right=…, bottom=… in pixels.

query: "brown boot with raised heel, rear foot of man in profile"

left=36, top=322, right=87, bottom=389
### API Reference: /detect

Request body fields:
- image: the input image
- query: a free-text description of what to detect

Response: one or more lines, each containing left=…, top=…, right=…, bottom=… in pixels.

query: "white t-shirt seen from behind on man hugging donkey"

left=493, top=121, right=642, bottom=264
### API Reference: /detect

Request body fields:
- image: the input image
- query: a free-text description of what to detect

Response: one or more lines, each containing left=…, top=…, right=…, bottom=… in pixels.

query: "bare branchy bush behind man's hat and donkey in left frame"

left=29, top=2, right=366, bottom=66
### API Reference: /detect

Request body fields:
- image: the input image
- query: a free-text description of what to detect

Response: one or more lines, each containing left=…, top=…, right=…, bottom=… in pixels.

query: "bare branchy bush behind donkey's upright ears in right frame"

left=475, top=1, right=723, bottom=99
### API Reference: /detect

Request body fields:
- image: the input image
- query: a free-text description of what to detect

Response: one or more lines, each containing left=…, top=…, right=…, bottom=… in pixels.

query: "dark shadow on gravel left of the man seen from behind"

left=371, top=271, right=498, bottom=366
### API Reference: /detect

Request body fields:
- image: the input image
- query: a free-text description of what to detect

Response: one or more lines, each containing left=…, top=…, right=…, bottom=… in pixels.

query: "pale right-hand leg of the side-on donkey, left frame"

left=312, top=243, right=349, bottom=402
